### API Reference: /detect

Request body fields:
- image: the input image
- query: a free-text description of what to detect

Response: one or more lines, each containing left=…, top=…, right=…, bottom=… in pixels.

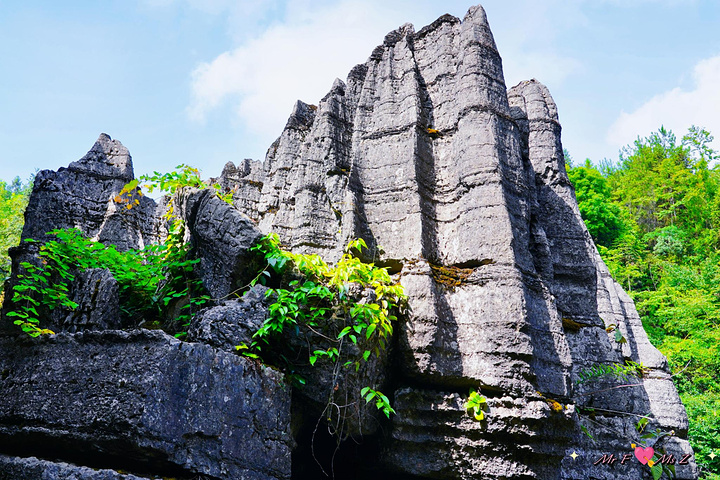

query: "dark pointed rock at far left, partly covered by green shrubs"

left=0, top=133, right=162, bottom=332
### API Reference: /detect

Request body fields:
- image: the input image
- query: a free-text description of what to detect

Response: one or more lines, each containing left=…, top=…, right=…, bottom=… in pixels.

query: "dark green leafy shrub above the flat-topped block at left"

left=8, top=226, right=209, bottom=336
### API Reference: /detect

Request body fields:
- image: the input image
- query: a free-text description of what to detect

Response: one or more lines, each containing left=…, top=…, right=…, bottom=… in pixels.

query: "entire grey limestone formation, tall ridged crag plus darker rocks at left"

left=0, top=6, right=697, bottom=480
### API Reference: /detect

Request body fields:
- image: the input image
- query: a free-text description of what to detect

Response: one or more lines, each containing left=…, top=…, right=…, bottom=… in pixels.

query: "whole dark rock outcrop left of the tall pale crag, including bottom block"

left=0, top=135, right=293, bottom=480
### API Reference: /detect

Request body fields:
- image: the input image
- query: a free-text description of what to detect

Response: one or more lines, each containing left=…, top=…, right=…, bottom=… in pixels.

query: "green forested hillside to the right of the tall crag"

left=567, top=127, right=720, bottom=479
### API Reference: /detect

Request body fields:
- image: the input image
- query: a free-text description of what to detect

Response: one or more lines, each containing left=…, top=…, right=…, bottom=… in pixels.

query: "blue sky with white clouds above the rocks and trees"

left=0, top=0, right=720, bottom=180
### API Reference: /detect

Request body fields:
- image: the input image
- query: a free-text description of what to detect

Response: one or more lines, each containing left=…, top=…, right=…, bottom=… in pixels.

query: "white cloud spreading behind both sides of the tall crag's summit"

left=184, top=0, right=587, bottom=154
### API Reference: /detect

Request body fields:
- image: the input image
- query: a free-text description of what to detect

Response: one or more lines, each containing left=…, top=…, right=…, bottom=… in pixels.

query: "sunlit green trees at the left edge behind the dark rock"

left=0, top=173, right=33, bottom=304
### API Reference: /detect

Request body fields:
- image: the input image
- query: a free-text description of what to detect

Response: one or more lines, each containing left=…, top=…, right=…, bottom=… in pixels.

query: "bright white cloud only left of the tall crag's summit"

left=188, top=1, right=422, bottom=144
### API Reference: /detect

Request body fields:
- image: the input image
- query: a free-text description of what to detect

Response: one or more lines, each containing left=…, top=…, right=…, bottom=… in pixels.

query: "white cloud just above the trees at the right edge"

left=607, top=55, right=720, bottom=150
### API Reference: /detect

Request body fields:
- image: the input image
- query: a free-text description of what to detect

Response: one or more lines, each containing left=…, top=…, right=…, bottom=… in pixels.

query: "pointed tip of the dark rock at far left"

left=68, top=133, right=135, bottom=182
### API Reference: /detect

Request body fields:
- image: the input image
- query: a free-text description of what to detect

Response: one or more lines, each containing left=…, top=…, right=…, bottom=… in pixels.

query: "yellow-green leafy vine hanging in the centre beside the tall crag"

left=245, top=234, right=406, bottom=428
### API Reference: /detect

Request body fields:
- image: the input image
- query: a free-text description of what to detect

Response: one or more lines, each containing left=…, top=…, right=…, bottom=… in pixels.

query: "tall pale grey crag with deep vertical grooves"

left=221, top=6, right=697, bottom=479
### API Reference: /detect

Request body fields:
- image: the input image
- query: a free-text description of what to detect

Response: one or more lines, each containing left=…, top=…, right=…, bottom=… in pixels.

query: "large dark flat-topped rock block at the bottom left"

left=0, top=330, right=292, bottom=480
